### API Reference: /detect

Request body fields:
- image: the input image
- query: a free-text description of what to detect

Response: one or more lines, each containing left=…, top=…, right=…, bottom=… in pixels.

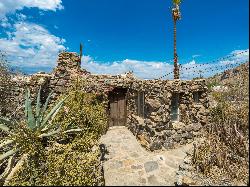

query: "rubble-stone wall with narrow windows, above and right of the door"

left=81, top=74, right=208, bottom=151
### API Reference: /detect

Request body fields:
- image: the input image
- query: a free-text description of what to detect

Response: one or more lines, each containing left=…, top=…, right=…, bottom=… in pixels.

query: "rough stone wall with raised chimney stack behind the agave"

left=7, top=52, right=90, bottom=119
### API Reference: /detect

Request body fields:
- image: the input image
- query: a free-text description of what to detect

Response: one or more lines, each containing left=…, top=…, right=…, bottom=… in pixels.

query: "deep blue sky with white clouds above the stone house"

left=0, top=0, right=249, bottom=78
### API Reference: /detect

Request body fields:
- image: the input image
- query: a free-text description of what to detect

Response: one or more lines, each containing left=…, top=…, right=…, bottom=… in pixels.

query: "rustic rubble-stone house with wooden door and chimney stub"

left=10, top=52, right=208, bottom=151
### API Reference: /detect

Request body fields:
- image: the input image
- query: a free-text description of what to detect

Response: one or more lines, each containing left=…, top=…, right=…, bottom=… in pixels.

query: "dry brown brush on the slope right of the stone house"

left=193, top=64, right=249, bottom=184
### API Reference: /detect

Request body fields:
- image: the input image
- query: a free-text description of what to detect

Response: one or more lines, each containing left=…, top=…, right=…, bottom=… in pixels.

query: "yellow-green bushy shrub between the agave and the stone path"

left=8, top=83, right=107, bottom=186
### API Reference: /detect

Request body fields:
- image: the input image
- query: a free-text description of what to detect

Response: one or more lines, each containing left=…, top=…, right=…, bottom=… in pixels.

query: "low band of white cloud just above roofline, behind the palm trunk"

left=82, top=50, right=249, bottom=80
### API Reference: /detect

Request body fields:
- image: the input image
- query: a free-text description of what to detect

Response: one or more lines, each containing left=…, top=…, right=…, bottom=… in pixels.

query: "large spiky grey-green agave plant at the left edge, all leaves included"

left=0, top=88, right=81, bottom=181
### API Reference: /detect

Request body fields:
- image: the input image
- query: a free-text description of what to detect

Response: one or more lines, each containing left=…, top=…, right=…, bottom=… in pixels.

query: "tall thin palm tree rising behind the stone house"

left=172, top=0, right=181, bottom=79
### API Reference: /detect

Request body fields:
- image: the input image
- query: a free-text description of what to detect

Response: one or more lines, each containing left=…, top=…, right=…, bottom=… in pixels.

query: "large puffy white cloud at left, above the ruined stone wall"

left=0, top=22, right=65, bottom=67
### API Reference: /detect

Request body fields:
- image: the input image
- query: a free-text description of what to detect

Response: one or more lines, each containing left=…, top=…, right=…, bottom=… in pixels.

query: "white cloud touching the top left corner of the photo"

left=0, top=0, right=63, bottom=20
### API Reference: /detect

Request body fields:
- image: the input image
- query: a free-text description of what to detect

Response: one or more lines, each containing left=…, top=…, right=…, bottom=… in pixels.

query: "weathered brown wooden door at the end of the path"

left=109, top=90, right=127, bottom=127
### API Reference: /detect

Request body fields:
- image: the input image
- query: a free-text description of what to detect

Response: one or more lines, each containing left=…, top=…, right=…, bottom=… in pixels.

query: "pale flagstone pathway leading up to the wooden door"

left=100, top=127, right=192, bottom=186
